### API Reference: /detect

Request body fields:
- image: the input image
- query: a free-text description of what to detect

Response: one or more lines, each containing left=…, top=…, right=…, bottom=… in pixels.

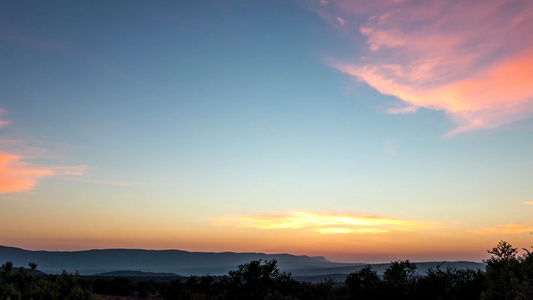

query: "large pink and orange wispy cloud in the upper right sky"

left=319, top=0, right=533, bottom=135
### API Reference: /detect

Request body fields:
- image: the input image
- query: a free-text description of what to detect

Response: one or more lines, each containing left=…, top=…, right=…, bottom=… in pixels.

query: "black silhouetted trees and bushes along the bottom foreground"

left=0, top=241, right=533, bottom=300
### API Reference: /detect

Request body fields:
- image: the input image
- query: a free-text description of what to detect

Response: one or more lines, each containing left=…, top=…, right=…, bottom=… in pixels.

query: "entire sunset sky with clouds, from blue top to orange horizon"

left=0, top=0, right=533, bottom=262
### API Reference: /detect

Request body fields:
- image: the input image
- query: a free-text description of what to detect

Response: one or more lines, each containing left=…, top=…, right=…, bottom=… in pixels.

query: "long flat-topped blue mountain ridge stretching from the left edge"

left=0, top=246, right=352, bottom=275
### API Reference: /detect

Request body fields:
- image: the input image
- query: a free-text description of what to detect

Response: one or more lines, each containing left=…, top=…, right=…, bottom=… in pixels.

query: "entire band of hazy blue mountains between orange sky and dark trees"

left=0, top=246, right=485, bottom=279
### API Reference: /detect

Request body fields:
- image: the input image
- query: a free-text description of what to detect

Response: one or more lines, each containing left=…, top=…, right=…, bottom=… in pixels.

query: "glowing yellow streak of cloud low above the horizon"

left=215, top=211, right=435, bottom=234
